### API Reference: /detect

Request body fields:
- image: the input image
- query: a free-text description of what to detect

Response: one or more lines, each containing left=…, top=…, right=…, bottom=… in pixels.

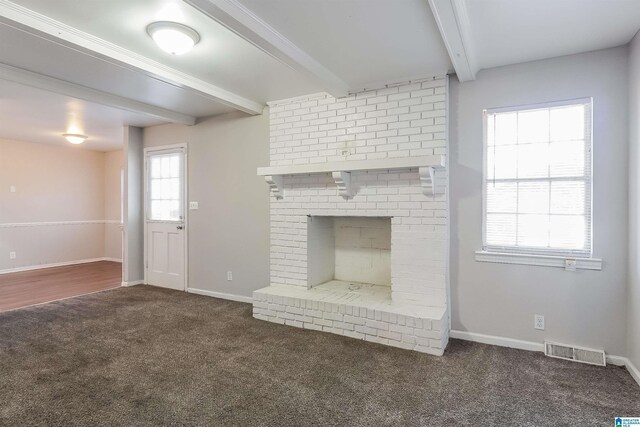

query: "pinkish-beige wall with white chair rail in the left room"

left=0, top=140, right=120, bottom=271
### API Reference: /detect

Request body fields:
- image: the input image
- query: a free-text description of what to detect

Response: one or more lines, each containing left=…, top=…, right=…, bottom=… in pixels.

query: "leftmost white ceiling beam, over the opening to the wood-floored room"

left=0, top=63, right=196, bottom=126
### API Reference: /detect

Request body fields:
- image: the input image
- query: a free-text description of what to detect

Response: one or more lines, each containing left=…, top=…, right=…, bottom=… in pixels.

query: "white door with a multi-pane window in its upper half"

left=145, top=148, right=186, bottom=290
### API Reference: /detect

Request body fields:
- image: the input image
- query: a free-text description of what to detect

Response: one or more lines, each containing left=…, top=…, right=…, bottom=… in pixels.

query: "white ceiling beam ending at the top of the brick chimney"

left=184, top=0, right=349, bottom=97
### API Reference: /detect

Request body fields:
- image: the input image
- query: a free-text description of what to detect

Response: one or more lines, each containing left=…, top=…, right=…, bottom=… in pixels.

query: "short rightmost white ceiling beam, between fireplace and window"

left=429, top=0, right=478, bottom=82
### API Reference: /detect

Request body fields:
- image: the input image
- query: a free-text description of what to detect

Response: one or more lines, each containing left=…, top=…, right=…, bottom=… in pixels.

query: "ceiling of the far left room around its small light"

left=0, top=80, right=162, bottom=151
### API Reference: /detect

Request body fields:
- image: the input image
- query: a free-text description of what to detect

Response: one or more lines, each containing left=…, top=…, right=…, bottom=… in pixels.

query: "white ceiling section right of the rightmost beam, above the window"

left=465, top=0, right=640, bottom=69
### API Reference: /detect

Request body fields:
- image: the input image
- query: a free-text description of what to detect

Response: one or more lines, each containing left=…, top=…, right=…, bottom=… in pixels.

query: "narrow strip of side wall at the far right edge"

left=627, top=33, right=640, bottom=368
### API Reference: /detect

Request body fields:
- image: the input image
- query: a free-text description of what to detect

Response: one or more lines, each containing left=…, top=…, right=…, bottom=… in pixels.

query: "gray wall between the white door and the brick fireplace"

left=144, top=110, right=269, bottom=297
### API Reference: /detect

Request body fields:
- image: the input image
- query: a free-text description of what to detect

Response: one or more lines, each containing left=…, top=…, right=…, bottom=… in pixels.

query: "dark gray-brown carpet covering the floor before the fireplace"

left=0, top=286, right=640, bottom=426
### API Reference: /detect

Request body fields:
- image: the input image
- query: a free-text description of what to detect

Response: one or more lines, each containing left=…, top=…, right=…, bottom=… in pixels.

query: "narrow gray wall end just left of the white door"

left=122, top=126, right=144, bottom=282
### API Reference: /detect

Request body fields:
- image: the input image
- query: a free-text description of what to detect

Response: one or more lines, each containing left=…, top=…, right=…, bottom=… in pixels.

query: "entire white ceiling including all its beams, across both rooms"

left=0, top=0, right=640, bottom=150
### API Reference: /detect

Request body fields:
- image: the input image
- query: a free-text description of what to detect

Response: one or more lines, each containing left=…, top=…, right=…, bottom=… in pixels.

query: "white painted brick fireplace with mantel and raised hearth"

left=253, top=77, right=449, bottom=355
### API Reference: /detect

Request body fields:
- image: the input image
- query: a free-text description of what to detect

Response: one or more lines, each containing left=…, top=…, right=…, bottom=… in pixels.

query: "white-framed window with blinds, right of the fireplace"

left=476, top=98, right=604, bottom=266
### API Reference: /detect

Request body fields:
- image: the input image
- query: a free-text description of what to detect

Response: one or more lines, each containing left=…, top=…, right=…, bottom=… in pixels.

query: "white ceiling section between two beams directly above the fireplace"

left=234, top=0, right=452, bottom=90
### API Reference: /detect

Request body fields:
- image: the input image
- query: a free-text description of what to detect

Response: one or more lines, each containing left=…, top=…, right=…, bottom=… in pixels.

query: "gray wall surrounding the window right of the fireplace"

left=450, top=47, right=628, bottom=355
